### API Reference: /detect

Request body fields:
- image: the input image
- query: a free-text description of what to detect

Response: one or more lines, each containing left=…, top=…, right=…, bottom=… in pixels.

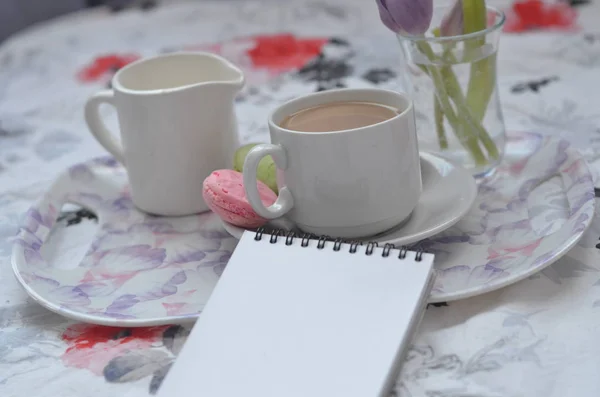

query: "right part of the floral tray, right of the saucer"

left=419, top=133, right=594, bottom=302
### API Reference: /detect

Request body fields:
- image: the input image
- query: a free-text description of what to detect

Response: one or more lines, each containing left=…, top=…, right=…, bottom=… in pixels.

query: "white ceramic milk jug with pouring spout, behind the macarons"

left=85, top=52, right=244, bottom=216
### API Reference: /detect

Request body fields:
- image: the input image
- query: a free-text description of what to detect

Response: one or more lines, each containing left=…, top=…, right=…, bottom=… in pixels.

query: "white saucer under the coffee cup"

left=223, top=153, right=477, bottom=246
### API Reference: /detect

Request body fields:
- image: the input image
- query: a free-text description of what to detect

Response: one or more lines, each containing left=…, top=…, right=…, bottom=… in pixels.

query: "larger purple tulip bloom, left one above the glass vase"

left=376, top=0, right=433, bottom=36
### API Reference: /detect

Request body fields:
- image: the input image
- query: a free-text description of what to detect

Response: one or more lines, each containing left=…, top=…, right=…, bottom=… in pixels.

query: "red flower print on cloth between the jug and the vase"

left=247, top=34, right=328, bottom=71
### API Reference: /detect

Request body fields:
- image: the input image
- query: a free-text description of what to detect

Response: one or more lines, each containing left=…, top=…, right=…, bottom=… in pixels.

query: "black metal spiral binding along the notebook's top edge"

left=254, top=227, right=425, bottom=262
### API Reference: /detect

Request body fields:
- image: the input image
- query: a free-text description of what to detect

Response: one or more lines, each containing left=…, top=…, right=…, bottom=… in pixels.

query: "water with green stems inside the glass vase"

left=412, top=52, right=506, bottom=177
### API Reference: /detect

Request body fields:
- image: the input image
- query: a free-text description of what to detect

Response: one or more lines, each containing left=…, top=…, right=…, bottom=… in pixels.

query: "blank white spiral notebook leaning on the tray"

left=158, top=232, right=434, bottom=397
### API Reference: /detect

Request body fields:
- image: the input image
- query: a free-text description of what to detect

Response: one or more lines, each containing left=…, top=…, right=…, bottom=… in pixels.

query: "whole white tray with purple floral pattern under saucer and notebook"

left=13, top=134, right=594, bottom=326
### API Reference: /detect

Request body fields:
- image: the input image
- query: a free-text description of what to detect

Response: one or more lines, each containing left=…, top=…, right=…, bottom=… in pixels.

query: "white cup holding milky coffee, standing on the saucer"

left=244, top=89, right=422, bottom=238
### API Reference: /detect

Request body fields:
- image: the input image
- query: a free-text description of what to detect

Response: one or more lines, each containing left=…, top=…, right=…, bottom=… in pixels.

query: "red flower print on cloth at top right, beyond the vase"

left=504, top=0, right=577, bottom=33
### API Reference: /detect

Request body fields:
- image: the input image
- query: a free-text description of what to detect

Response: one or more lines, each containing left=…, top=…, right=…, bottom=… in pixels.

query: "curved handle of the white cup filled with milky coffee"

left=243, top=143, right=294, bottom=219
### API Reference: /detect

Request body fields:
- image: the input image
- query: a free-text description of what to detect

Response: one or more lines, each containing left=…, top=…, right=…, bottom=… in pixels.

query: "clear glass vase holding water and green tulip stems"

left=398, top=5, right=506, bottom=178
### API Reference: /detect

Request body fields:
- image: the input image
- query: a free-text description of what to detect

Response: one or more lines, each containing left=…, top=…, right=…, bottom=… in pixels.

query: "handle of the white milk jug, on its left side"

left=85, top=90, right=125, bottom=164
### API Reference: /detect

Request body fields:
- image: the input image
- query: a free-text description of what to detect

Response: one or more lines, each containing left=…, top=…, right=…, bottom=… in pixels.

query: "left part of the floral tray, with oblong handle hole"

left=13, top=158, right=236, bottom=325
